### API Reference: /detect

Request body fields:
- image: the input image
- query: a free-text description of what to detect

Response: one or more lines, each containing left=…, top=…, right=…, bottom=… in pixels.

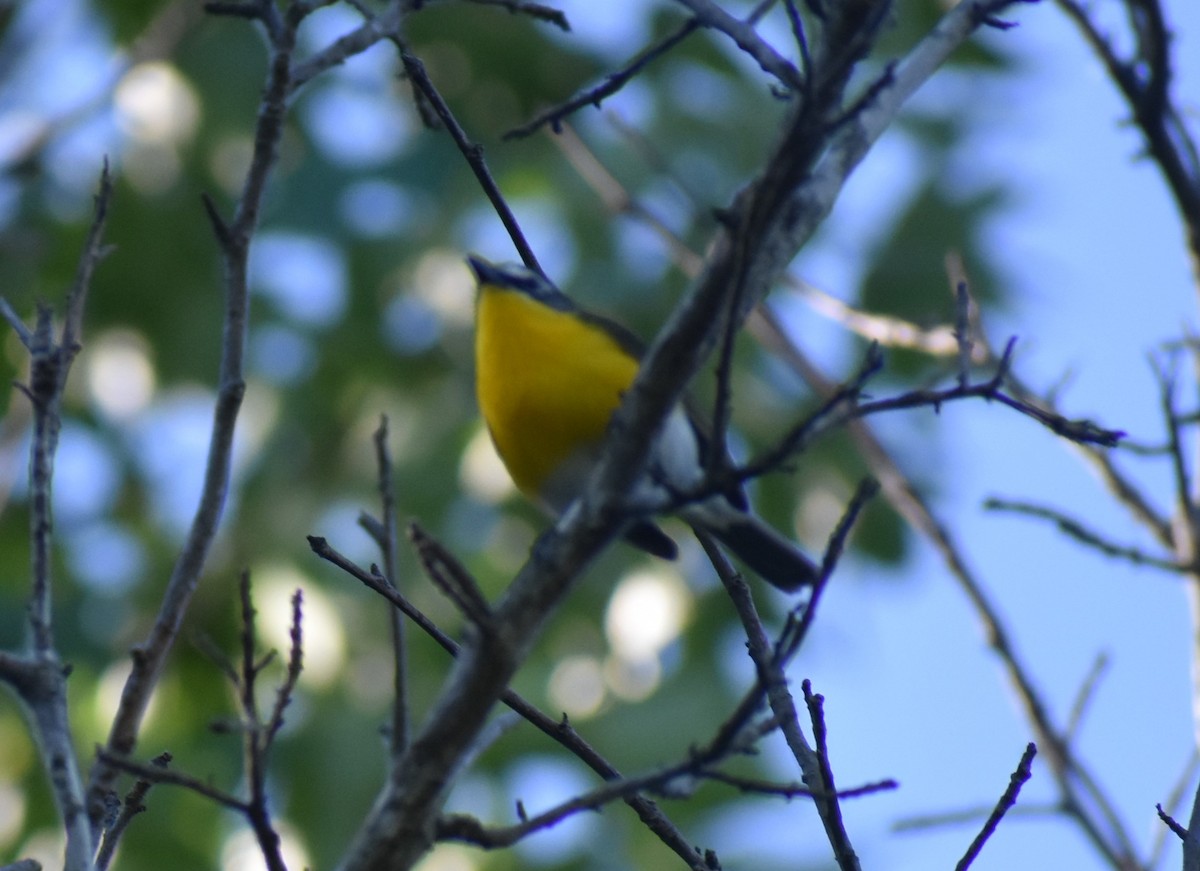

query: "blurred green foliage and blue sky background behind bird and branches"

left=0, top=0, right=1200, bottom=871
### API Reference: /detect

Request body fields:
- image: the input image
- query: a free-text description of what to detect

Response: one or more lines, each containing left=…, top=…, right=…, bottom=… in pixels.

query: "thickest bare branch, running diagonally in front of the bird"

left=343, top=0, right=1032, bottom=871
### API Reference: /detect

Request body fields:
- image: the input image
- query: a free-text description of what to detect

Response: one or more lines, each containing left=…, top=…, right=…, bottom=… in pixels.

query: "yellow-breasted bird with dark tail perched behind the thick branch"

left=467, top=254, right=821, bottom=591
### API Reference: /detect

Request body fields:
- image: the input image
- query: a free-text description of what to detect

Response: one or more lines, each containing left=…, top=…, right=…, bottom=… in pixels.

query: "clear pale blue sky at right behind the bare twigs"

left=794, top=2, right=1200, bottom=871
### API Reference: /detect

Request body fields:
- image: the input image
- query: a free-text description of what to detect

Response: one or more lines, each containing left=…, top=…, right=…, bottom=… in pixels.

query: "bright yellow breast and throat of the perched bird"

left=475, top=287, right=637, bottom=501
